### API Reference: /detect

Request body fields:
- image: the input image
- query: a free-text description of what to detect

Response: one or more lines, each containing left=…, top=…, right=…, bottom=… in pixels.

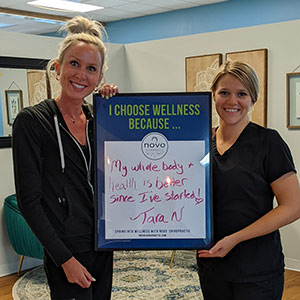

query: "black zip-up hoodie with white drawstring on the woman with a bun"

left=12, top=99, right=94, bottom=266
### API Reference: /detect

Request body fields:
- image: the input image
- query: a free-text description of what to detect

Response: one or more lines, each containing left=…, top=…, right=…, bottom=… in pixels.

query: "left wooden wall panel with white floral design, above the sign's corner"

left=185, top=53, right=222, bottom=127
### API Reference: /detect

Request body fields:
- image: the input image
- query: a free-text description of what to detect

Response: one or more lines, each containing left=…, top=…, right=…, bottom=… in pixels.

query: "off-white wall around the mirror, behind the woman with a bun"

left=0, top=31, right=128, bottom=276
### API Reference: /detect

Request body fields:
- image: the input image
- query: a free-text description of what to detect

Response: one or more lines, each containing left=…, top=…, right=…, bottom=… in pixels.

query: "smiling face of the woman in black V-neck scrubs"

left=213, top=74, right=253, bottom=126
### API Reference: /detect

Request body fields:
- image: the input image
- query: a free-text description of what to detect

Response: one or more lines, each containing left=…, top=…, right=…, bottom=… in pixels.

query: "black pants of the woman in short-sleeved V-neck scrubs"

left=199, top=272, right=284, bottom=300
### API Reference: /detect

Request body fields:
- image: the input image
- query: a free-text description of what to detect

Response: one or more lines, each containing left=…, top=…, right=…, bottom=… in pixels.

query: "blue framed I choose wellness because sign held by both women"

left=94, top=92, right=212, bottom=250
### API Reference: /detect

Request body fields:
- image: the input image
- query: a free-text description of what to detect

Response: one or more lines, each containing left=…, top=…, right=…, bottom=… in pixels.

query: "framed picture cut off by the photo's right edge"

left=286, top=73, right=300, bottom=129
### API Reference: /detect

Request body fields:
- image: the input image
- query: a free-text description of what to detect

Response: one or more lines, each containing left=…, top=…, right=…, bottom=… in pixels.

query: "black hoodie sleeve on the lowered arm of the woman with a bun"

left=12, top=111, right=72, bottom=265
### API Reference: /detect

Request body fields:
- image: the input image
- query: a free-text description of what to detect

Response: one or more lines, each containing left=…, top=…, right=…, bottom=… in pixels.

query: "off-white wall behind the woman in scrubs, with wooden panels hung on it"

left=125, top=21, right=300, bottom=271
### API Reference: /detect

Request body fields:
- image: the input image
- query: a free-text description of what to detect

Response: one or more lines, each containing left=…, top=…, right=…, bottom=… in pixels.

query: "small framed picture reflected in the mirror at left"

left=5, top=90, right=23, bottom=125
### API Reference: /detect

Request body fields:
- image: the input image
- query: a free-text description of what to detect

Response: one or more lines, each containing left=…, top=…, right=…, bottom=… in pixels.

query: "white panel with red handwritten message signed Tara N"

left=104, top=141, right=206, bottom=239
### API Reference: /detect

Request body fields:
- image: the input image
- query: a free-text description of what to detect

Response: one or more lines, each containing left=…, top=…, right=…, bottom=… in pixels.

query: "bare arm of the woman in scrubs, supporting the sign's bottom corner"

left=198, top=172, right=300, bottom=257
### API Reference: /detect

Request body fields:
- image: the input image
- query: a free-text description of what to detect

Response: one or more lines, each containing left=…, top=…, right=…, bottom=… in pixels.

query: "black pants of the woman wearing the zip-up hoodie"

left=44, top=251, right=113, bottom=300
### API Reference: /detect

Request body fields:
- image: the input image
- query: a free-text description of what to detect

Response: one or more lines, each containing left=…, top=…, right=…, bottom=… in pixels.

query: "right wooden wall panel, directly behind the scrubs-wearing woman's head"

left=225, top=49, right=268, bottom=127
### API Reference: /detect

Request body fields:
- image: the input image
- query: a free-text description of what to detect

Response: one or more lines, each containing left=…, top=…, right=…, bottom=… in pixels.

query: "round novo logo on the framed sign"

left=142, top=132, right=169, bottom=160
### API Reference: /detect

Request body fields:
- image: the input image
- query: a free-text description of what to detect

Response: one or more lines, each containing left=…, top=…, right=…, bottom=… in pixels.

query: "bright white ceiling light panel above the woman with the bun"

left=27, top=0, right=104, bottom=12
